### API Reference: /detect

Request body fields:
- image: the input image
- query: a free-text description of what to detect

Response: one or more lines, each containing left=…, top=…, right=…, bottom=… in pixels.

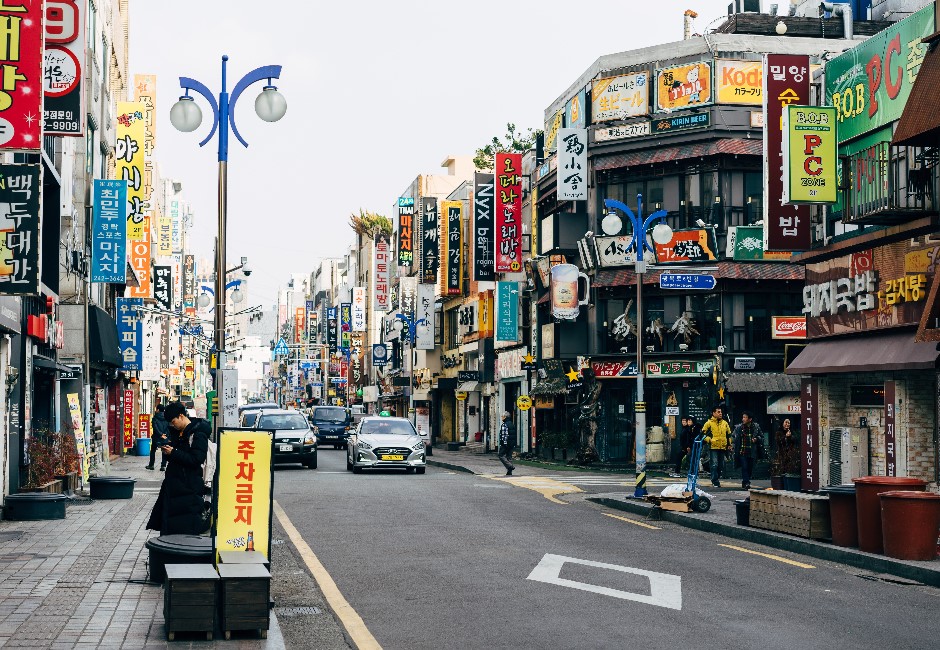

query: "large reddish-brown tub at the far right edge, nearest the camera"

left=879, top=491, right=940, bottom=561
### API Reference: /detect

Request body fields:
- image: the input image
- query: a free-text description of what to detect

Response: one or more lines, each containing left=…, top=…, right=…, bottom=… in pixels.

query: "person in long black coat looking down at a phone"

left=147, top=402, right=212, bottom=535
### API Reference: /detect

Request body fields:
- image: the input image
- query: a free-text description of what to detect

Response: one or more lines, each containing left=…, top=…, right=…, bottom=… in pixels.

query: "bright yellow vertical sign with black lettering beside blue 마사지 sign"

left=114, top=102, right=146, bottom=241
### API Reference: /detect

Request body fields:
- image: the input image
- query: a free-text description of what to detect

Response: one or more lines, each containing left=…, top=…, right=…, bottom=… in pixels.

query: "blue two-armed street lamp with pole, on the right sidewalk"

left=604, top=194, right=672, bottom=498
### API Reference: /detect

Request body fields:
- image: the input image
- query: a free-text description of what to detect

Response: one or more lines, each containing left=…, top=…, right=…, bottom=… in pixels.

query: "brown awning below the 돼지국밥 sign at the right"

left=786, top=331, right=937, bottom=375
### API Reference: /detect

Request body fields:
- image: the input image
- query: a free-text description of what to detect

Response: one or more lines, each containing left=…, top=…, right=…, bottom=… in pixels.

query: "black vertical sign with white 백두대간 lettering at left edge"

left=0, top=163, right=41, bottom=295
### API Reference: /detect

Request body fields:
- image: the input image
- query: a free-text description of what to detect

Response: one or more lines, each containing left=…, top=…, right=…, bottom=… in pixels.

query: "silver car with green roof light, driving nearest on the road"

left=346, top=416, right=427, bottom=474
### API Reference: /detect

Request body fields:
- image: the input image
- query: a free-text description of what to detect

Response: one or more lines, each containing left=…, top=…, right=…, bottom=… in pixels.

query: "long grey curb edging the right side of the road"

left=587, top=497, right=940, bottom=587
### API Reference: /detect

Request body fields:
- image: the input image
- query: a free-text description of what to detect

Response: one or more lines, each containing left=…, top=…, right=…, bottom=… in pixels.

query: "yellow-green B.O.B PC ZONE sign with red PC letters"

left=783, top=105, right=839, bottom=204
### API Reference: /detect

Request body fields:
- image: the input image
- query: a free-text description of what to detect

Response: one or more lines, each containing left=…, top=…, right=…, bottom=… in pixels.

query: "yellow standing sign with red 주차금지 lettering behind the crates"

left=215, top=430, right=273, bottom=557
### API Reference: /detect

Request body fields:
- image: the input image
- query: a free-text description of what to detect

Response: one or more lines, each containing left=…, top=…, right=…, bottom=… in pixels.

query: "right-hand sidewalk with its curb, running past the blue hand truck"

left=428, top=448, right=940, bottom=587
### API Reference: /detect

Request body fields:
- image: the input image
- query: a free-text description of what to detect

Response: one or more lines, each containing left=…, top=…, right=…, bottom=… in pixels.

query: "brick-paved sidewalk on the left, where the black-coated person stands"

left=0, top=456, right=284, bottom=650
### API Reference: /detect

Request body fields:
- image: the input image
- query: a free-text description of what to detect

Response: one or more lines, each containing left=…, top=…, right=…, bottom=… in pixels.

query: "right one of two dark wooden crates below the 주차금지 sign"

left=219, top=563, right=271, bottom=639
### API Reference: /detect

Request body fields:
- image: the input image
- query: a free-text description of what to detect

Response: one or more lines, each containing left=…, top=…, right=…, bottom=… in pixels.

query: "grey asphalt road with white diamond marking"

left=275, top=449, right=940, bottom=650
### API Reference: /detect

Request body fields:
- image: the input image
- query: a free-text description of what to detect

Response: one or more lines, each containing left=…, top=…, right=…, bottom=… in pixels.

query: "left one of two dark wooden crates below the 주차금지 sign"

left=163, top=564, right=219, bottom=641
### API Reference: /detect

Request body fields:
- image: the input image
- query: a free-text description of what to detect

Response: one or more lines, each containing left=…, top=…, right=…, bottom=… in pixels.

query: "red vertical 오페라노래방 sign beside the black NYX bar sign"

left=496, top=153, right=522, bottom=273
